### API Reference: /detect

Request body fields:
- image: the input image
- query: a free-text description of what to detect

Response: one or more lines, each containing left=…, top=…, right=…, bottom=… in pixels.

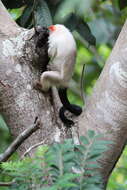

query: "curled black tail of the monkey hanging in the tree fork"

left=58, top=88, right=82, bottom=125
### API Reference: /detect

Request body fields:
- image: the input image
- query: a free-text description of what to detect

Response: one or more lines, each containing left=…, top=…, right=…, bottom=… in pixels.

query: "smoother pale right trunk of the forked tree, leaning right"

left=79, top=21, right=127, bottom=184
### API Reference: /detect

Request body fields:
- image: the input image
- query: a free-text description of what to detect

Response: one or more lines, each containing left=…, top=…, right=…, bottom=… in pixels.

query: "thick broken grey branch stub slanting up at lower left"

left=0, top=117, right=40, bottom=162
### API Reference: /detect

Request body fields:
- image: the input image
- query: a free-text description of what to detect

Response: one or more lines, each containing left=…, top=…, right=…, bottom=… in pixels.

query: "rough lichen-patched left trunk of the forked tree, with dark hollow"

left=0, top=1, right=64, bottom=157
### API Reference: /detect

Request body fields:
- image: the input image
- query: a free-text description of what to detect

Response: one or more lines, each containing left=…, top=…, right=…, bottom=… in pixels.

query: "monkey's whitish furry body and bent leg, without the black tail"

left=40, top=24, right=76, bottom=91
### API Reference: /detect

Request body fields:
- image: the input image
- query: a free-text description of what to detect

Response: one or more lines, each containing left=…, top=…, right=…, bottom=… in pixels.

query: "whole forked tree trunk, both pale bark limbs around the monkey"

left=0, top=1, right=127, bottom=185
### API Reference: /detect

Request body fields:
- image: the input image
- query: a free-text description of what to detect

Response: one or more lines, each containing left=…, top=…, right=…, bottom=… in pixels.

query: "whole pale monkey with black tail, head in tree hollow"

left=35, top=24, right=82, bottom=127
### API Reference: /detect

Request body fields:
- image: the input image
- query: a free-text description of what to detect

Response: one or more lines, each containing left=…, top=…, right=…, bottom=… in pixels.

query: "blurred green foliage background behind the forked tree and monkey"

left=0, top=0, right=127, bottom=190
